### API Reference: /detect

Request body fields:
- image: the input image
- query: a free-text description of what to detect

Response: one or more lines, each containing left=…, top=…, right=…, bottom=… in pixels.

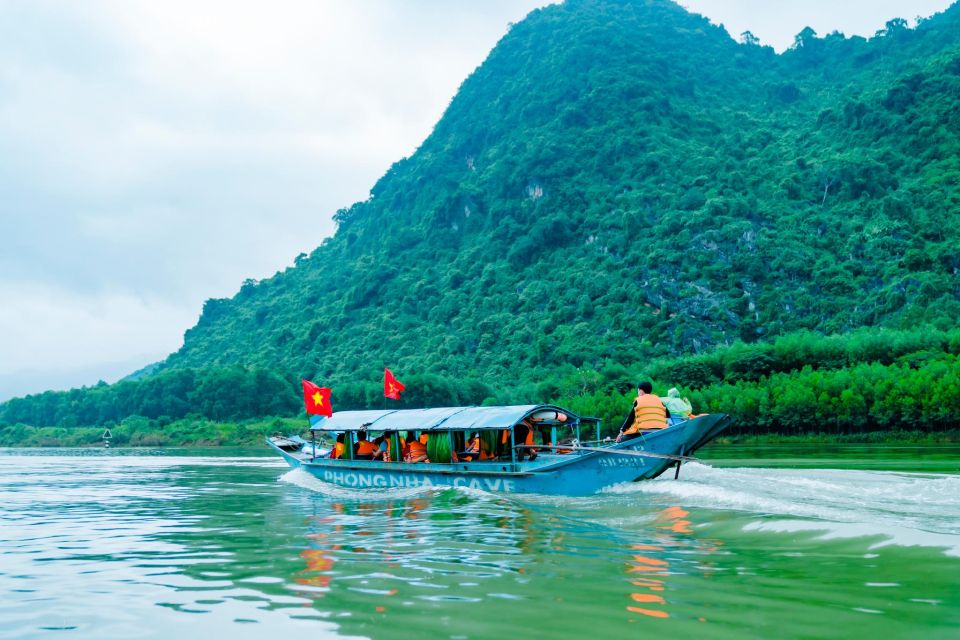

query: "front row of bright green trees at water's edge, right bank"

left=558, top=351, right=960, bottom=438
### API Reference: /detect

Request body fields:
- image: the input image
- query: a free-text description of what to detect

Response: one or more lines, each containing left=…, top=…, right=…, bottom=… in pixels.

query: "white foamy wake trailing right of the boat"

left=610, top=463, right=960, bottom=556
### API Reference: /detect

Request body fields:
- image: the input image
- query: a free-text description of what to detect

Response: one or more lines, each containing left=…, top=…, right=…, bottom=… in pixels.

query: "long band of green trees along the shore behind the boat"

left=0, top=327, right=960, bottom=447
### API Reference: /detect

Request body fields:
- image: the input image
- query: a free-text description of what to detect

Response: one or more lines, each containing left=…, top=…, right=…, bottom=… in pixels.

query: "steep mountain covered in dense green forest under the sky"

left=0, top=0, right=960, bottom=438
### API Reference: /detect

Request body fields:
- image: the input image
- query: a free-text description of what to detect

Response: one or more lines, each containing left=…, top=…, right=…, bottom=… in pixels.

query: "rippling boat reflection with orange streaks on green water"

left=293, top=480, right=722, bottom=638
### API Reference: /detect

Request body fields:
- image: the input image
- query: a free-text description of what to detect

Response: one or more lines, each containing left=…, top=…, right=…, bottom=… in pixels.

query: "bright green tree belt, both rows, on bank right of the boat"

left=559, top=329, right=960, bottom=434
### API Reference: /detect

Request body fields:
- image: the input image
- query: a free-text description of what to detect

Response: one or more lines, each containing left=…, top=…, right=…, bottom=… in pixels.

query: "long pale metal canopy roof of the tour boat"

left=310, top=404, right=580, bottom=431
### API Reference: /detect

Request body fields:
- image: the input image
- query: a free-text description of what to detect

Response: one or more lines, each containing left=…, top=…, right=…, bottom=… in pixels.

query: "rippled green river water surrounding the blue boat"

left=0, top=446, right=960, bottom=640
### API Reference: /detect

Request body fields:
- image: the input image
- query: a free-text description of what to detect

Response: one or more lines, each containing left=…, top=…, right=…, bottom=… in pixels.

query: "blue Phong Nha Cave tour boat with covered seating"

left=267, top=405, right=731, bottom=496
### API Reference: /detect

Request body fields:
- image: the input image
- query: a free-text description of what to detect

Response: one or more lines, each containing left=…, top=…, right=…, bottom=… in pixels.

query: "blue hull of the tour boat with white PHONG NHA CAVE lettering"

left=267, top=414, right=730, bottom=496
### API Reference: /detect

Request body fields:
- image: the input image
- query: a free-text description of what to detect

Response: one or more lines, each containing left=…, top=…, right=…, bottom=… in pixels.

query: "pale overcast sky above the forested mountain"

left=0, top=0, right=950, bottom=400
